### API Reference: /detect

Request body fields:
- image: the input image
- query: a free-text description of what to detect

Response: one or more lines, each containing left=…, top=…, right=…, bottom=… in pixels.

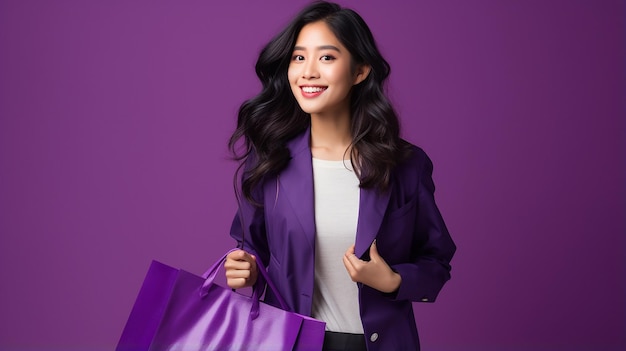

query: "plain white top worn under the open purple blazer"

left=312, top=158, right=363, bottom=334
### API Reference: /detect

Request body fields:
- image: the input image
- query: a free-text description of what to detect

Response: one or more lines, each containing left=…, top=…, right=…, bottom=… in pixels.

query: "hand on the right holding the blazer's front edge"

left=343, top=240, right=402, bottom=293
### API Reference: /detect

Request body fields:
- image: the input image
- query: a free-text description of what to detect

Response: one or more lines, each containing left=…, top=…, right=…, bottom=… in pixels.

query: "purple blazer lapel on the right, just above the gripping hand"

left=354, top=189, right=391, bottom=258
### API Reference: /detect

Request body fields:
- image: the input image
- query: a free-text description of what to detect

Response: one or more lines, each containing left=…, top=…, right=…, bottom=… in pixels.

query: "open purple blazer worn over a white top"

left=231, top=130, right=456, bottom=351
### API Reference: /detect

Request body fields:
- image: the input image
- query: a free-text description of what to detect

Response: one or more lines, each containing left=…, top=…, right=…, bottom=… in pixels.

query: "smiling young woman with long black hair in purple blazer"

left=225, top=2, right=456, bottom=351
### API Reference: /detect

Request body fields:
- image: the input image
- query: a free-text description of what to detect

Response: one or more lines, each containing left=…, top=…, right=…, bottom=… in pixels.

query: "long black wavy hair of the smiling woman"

left=228, top=1, right=410, bottom=203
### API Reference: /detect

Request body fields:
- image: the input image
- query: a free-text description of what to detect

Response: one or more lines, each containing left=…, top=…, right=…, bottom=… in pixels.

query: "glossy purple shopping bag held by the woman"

left=116, top=250, right=325, bottom=351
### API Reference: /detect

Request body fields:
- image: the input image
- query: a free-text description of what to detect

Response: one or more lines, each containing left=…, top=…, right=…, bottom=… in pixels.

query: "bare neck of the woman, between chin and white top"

left=311, top=113, right=352, bottom=160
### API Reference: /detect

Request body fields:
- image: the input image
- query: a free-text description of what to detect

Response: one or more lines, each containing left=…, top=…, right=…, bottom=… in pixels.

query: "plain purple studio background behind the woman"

left=0, top=0, right=626, bottom=351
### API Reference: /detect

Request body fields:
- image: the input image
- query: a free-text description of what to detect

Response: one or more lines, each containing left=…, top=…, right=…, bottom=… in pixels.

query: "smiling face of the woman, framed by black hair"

left=288, top=21, right=369, bottom=114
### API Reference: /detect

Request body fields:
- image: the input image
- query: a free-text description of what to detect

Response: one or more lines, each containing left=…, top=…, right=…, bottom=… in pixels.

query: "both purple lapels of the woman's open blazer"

left=278, top=128, right=390, bottom=257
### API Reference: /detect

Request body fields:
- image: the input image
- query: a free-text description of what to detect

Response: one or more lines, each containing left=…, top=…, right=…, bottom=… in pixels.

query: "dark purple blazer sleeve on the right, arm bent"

left=391, top=150, right=456, bottom=302
